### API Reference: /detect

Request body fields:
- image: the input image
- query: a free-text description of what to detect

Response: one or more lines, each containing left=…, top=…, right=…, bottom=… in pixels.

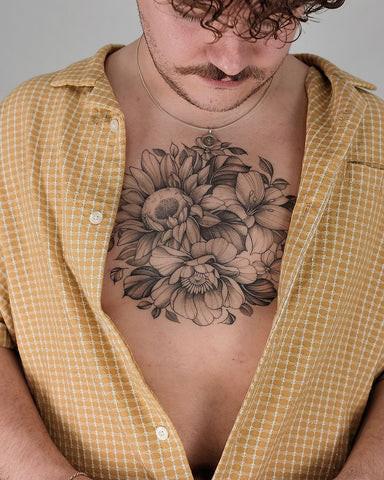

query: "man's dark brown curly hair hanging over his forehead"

left=166, top=0, right=345, bottom=42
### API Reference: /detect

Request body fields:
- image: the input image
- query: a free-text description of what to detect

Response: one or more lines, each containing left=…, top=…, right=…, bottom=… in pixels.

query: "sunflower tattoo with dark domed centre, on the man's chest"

left=110, top=145, right=220, bottom=266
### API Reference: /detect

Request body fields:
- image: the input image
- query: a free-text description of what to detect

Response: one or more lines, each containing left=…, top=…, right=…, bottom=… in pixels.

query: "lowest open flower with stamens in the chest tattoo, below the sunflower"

left=150, top=238, right=257, bottom=325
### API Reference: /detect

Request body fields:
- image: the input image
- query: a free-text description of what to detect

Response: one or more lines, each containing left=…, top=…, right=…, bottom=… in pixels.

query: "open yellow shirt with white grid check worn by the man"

left=0, top=44, right=384, bottom=480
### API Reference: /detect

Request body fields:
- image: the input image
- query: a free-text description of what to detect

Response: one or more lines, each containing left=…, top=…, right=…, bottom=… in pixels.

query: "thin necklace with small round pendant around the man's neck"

left=136, top=36, right=273, bottom=148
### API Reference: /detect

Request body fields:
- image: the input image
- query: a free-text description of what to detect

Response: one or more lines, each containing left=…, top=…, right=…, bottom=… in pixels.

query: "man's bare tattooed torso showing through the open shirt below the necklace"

left=102, top=42, right=307, bottom=480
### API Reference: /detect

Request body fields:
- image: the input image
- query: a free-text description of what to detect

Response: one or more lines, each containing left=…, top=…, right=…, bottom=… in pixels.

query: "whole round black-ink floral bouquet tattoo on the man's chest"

left=108, top=137, right=296, bottom=325
